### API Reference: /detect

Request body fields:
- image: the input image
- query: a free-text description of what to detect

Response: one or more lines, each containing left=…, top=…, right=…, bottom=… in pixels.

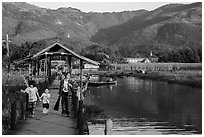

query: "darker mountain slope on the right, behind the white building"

left=91, top=3, right=202, bottom=57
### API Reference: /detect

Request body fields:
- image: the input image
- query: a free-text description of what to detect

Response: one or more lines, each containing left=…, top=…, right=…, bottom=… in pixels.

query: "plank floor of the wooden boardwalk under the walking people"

left=6, top=80, right=78, bottom=135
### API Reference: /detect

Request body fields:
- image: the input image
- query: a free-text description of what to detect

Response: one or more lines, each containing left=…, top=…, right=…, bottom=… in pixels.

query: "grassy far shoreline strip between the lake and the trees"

left=83, top=70, right=202, bottom=88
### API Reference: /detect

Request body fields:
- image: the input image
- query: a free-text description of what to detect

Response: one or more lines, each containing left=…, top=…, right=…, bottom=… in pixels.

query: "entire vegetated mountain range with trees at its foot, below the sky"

left=2, top=2, right=202, bottom=63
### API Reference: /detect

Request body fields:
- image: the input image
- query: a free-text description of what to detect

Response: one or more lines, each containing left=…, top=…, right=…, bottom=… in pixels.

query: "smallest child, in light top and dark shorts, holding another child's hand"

left=40, top=88, right=50, bottom=115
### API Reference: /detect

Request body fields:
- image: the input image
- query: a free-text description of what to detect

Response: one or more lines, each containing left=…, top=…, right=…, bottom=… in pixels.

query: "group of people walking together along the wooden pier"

left=21, top=69, right=89, bottom=117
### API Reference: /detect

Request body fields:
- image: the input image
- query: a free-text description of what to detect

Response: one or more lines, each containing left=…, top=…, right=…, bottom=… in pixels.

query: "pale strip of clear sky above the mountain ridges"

left=28, top=0, right=193, bottom=12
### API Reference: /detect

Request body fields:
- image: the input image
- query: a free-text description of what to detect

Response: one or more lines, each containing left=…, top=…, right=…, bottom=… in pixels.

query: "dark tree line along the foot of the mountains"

left=2, top=41, right=202, bottom=64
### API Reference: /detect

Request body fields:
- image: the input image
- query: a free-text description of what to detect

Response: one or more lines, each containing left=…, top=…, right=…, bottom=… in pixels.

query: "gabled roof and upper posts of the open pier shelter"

left=14, top=42, right=100, bottom=82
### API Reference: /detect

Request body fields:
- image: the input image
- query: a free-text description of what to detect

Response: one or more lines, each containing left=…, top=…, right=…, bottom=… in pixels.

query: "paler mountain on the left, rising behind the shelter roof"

left=2, top=2, right=147, bottom=50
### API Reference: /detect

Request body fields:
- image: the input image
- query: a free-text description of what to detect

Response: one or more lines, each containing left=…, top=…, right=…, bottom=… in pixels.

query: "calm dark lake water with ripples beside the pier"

left=83, top=77, right=202, bottom=134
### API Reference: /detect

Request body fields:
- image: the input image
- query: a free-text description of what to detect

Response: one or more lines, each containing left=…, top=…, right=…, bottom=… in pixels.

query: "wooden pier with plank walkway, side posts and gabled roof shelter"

left=3, top=43, right=99, bottom=135
